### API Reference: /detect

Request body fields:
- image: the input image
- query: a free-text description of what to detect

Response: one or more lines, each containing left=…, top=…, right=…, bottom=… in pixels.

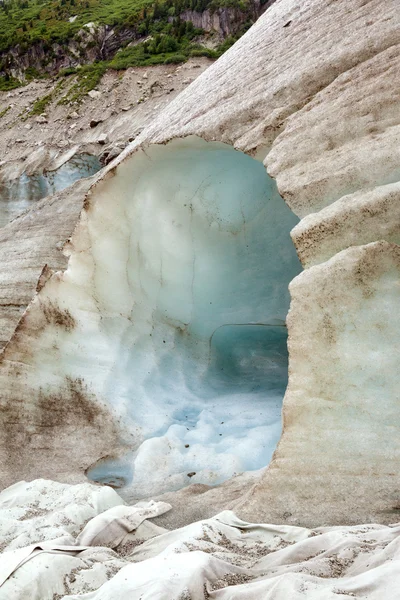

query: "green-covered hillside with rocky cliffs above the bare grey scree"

left=0, top=0, right=274, bottom=85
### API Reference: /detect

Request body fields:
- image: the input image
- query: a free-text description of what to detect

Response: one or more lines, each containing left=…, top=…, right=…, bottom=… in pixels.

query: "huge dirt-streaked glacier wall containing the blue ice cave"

left=0, top=0, right=400, bottom=540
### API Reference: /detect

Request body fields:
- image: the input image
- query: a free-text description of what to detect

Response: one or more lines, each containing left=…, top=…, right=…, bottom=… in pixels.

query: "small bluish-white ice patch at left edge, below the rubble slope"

left=0, top=154, right=101, bottom=227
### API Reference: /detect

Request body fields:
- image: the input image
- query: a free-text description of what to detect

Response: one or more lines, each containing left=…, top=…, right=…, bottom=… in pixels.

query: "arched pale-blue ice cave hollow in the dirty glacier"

left=88, top=138, right=301, bottom=497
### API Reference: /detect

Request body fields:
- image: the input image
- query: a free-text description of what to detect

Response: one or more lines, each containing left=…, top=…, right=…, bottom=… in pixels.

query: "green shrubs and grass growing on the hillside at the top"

left=0, top=0, right=254, bottom=101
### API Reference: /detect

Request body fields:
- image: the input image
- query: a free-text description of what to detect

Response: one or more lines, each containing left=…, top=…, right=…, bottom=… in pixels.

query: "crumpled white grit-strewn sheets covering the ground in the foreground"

left=0, top=479, right=400, bottom=600
